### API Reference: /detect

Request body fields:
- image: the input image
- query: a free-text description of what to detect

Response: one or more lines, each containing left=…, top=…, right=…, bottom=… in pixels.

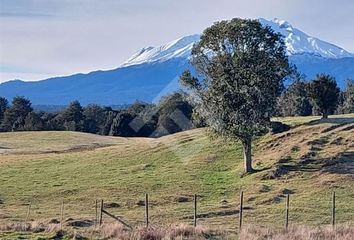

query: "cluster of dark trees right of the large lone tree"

left=276, top=74, right=354, bottom=118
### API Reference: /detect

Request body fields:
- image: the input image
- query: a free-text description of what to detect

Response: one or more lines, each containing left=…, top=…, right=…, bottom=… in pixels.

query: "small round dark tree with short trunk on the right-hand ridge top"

left=308, top=74, right=340, bottom=119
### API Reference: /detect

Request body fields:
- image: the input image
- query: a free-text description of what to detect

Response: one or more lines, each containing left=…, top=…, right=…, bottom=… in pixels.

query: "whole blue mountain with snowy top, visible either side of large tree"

left=0, top=19, right=354, bottom=105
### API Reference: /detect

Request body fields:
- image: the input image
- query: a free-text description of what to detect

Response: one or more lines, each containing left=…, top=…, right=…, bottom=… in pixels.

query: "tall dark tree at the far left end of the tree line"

left=2, top=97, right=33, bottom=131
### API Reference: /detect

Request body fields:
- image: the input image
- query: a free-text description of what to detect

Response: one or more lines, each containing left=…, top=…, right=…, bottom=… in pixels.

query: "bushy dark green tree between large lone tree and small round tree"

left=277, top=80, right=312, bottom=116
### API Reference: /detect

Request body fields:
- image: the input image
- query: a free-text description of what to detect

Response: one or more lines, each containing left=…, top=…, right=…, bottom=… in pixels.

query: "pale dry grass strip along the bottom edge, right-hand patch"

left=240, top=225, right=354, bottom=240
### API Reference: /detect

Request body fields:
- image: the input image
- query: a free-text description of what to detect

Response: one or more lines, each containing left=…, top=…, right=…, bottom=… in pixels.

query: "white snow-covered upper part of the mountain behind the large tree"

left=122, top=18, right=354, bottom=66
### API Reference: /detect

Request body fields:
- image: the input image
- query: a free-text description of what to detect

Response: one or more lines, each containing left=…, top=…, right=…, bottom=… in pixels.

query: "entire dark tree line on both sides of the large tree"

left=0, top=74, right=354, bottom=137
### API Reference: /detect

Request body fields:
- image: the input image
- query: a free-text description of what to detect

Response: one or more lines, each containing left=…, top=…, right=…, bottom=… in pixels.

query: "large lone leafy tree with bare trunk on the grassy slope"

left=180, top=18, right=293, bottom=173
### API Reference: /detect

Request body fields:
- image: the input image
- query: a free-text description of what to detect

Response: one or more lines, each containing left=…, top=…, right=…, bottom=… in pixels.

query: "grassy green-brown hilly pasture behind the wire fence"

left=0, top=115, right=354, bottom=239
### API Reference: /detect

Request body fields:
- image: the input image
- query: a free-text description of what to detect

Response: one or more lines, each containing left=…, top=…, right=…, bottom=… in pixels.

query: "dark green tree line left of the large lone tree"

left=0, top=92, right=194, bottom=137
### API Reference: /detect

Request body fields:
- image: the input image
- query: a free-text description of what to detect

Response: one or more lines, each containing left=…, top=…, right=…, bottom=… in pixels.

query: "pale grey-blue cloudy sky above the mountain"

left=0, top=0, right=354, bottom=82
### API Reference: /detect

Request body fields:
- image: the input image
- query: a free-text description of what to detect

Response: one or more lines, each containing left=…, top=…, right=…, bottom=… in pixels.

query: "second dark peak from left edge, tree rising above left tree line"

left=61, top=101, right=84, bottom=131
